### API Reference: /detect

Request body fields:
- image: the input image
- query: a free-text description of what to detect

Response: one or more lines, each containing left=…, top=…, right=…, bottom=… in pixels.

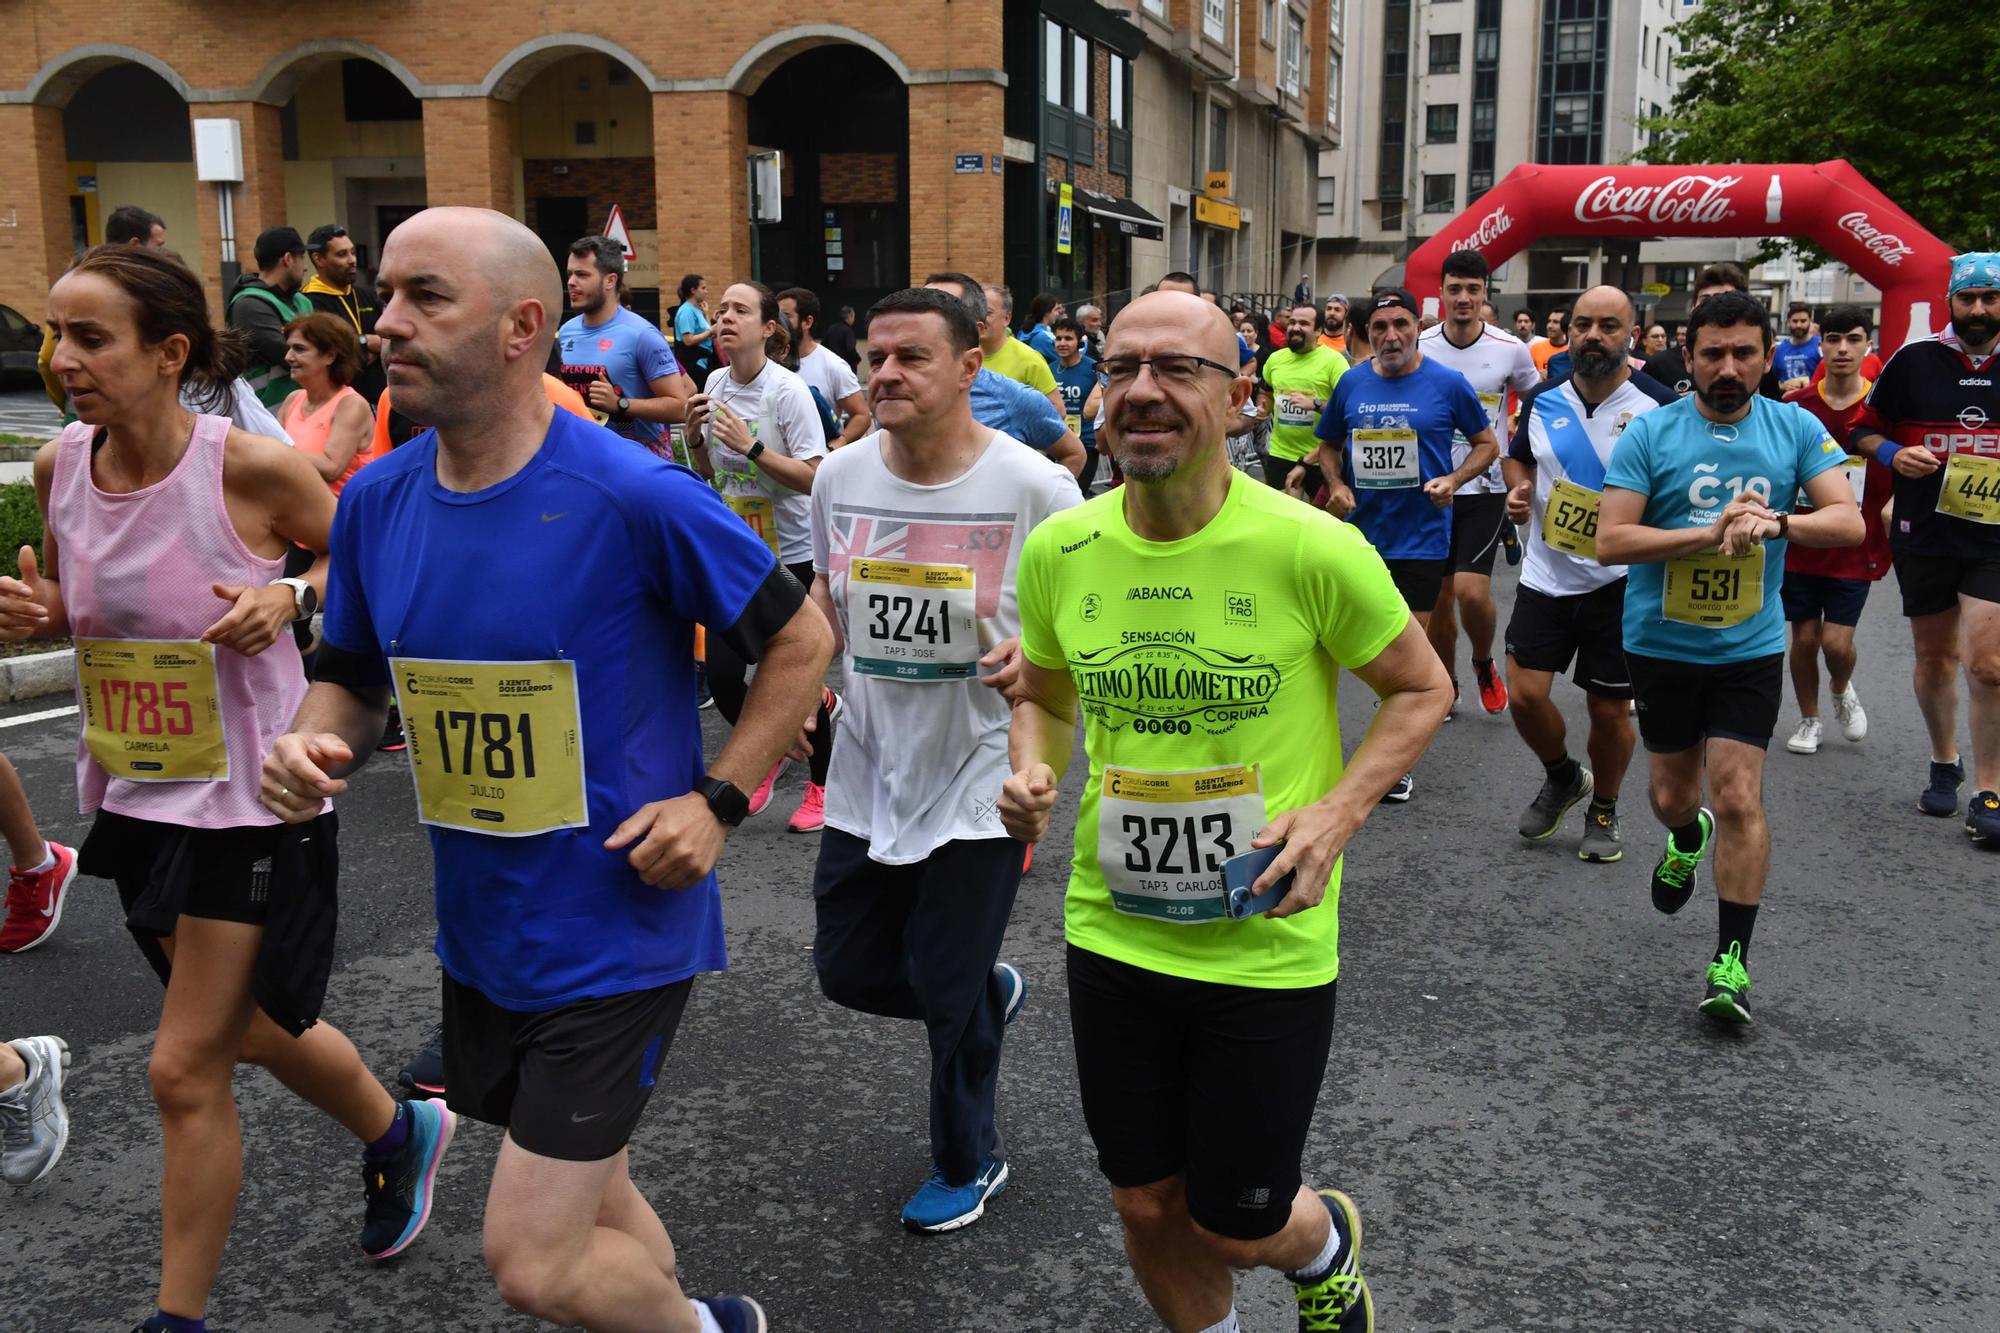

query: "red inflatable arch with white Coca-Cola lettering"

left=1404, top=160, right=1952, bottom=356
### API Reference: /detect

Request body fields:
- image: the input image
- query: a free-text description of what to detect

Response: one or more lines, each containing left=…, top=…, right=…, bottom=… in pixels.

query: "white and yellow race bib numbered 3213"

left=1098, top=765, right=1264, bottom=925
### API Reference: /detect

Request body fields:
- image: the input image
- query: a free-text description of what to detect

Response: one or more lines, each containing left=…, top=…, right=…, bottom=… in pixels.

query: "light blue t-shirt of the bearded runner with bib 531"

left=1604, top=396, right=1848, bottom=662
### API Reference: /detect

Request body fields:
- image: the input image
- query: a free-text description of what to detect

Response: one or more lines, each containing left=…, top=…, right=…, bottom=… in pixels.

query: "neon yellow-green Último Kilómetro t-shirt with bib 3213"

left=1018, top=472, right=1410, bottom=989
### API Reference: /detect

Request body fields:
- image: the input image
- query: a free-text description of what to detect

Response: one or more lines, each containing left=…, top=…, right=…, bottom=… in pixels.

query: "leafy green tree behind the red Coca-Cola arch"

left=1640, top=0, right=2000, bottom=260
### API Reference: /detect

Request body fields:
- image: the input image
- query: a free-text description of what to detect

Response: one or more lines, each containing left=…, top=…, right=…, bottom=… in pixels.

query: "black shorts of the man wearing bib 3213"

left=1070, top=940, right=1338, bottom=1241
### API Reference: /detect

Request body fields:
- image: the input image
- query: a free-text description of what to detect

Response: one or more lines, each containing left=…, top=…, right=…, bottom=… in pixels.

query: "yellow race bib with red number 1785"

left=76, top=638, right=230, bottom=783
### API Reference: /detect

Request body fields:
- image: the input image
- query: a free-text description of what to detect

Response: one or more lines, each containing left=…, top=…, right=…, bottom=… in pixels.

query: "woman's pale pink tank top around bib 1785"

left=48, top=416, right=306, bottom=829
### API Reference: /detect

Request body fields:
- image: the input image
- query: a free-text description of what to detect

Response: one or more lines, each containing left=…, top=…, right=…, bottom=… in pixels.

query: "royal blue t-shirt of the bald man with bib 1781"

left=326, top=412, right=776, bottom=1011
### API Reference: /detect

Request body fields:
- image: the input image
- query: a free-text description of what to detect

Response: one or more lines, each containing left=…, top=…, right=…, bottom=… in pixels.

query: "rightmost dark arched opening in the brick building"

left=750, top=44, right=912, bottom=310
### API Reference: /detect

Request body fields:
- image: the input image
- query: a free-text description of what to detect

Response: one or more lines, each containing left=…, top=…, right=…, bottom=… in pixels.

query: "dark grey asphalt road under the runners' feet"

left=0, top=576, right=2000, bottom=1333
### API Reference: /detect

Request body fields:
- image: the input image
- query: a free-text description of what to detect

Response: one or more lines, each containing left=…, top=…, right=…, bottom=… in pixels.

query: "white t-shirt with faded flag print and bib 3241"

left=812, top=426, right=1082, bottom=865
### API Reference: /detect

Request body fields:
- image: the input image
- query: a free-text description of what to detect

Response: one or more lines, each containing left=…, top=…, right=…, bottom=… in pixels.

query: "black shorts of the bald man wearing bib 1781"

left=444, top=975, right=694, bottom=1161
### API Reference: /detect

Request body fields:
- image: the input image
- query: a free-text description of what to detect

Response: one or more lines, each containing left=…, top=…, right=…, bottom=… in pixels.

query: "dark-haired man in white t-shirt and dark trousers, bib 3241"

left=812, top=288, right=1078, bottom=1233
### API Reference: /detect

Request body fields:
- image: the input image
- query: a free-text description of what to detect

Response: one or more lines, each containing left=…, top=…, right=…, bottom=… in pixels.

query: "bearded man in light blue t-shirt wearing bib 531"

left=1598, top=292, right=1862, bottom=1023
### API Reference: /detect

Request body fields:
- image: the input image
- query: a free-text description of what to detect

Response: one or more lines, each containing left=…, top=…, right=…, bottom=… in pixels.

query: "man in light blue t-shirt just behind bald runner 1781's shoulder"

left=556, top=236, right=694, bottom=458
